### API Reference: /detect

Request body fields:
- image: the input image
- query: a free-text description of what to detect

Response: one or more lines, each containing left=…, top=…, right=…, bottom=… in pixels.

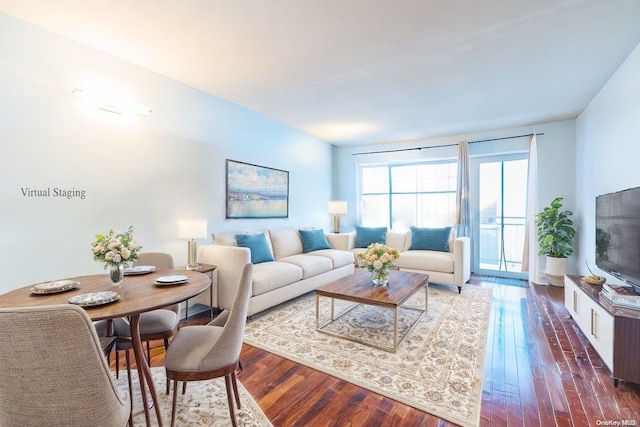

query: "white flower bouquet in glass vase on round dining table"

left=91, top=226, right=142, bottom=286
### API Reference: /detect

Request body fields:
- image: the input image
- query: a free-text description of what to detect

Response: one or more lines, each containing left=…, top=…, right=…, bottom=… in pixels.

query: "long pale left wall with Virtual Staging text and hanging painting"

left=0, top=14, right=333, bottom=293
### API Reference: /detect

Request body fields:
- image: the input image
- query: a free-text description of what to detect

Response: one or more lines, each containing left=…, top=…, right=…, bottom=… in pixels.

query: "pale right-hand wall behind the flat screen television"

left=576, top=41, right=640, bottom=282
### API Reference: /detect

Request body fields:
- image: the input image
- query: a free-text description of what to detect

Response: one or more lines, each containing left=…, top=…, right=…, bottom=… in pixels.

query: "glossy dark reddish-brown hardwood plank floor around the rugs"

left=130, top=276, right=640, bottom=427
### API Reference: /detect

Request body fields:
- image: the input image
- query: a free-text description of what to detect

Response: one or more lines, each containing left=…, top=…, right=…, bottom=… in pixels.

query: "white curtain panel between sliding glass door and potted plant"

left=522, top=135, right=540, bottom=283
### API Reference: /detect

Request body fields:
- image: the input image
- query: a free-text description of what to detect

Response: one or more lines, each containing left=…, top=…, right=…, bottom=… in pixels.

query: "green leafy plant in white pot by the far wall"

left=536, top=197, right=576, bottom=286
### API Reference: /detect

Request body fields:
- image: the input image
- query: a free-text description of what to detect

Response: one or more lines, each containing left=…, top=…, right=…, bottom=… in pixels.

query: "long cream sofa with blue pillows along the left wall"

left=198, top=228, right=354, bottom=316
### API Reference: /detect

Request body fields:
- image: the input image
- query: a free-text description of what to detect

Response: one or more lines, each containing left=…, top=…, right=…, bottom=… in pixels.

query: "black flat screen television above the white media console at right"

left=596, top=187, right=640, bottom=291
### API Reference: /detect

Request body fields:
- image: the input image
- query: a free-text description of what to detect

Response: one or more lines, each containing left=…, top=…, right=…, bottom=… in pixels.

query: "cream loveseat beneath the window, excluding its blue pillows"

left=329, top=229, right=471, bottom=292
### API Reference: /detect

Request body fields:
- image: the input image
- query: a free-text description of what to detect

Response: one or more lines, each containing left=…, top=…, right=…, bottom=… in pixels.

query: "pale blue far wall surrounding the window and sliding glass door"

left=334, top=120, right=578, bottom=272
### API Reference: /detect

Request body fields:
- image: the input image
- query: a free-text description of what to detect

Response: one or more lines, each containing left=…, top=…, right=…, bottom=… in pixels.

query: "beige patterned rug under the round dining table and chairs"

left=116, top=367, right=271, bottom=427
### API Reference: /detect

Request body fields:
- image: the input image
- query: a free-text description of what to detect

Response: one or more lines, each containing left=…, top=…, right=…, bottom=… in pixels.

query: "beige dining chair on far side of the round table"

left=113, top=252, right=180, bottom=394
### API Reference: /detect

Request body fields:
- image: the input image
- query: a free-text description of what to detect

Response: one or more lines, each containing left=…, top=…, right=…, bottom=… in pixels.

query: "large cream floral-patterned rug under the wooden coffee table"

left=244, top=285, right=491, bottom=426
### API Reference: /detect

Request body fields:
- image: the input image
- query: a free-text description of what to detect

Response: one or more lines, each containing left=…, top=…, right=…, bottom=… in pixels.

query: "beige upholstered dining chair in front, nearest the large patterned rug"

left=164, top=264, right=253, bottom=427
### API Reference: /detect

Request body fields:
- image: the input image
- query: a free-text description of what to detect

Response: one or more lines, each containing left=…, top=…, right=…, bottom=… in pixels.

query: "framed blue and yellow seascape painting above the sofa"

left=227, top=159, right=289, bottom=218
